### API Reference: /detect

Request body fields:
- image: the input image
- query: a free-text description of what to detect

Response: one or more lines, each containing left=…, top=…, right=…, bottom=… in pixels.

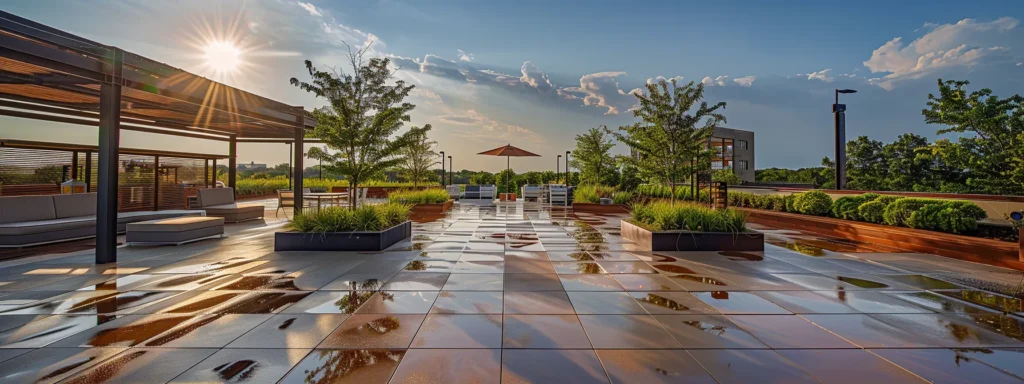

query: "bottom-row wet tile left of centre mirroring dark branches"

left=281, top=349, right=406, bottom=384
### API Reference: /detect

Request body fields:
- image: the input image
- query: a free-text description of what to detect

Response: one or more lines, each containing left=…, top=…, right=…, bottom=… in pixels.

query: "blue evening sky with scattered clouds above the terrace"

left=0, top=0, right=1024, bottom=171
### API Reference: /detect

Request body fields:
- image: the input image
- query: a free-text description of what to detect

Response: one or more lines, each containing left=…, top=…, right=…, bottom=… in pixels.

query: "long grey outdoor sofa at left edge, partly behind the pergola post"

left=0, top=194, right=204, bottom=248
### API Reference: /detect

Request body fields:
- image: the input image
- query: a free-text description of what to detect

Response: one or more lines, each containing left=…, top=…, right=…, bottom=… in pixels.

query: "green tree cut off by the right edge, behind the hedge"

left=921, top=79, right=1024, bottom=195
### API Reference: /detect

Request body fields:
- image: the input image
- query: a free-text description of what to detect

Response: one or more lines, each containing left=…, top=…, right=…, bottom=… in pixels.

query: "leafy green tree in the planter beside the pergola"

left=291, top=45, right=425, bottom=209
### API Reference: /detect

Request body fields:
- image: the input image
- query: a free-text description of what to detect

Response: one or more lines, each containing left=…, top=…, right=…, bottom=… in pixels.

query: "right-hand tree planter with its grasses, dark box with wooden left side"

left=621, top=202, right=764, bottom=252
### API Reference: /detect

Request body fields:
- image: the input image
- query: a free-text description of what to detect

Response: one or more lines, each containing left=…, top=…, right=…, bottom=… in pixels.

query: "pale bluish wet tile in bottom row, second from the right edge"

left=871, top=349, right=1019, bottom=383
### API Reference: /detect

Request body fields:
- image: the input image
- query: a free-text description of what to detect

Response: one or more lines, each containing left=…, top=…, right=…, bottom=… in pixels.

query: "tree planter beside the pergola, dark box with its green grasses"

left=273, top=203, right=413, bottom=251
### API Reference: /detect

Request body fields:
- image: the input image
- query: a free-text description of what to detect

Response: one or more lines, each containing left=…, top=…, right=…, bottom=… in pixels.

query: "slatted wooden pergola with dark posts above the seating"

left=0, top=11, right=314, bottom=264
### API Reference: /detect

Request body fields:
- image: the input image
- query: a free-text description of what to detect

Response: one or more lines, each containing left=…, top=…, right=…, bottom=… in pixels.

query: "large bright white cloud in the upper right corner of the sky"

left=864, top=17, right=1020, bottom=89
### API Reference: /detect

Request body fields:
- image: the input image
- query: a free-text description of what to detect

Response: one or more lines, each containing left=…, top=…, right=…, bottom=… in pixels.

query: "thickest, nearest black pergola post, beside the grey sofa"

left=96, top=48, right=124, bottom=264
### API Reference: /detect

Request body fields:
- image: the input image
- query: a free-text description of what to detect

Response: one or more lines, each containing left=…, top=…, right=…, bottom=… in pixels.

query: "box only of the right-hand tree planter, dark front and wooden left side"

left=621, top=220, right=765, bottom=252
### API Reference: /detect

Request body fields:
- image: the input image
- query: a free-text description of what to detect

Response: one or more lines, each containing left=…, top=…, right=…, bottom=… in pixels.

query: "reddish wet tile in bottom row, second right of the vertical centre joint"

left=597, top=350, right=715, bottom=384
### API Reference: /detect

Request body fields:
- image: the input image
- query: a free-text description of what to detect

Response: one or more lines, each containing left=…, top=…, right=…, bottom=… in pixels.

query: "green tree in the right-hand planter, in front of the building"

left=614, top=79, right=726, bottom=203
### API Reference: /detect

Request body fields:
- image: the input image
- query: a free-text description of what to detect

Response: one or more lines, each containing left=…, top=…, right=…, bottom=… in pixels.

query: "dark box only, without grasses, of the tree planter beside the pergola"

left=273, top=221, right=413, bottom=252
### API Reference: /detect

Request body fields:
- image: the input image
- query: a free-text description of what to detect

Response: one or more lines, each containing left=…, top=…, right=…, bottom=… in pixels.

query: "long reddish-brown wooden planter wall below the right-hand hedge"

left=735, top=208, right=1024, bottom=270
